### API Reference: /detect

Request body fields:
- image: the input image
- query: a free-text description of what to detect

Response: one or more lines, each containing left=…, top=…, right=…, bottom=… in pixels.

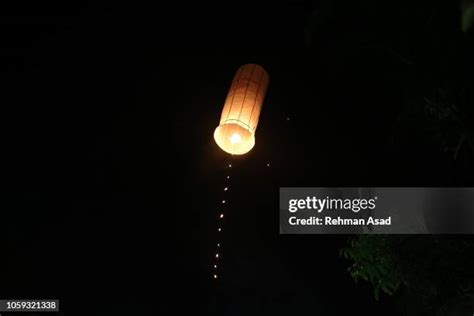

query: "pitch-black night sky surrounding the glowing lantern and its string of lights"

left=0, top=0, right=473, bottom=315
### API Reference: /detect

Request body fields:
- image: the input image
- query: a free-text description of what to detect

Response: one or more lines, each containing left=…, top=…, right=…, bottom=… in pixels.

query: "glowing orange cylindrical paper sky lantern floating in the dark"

left=214, top=64, right=268, bottom=155
